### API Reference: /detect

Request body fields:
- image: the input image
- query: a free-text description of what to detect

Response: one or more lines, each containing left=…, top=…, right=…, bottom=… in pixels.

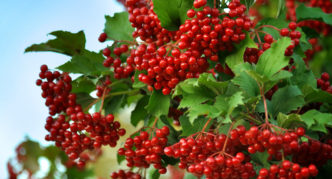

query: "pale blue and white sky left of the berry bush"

left=0, top=0, right=123, bottom=178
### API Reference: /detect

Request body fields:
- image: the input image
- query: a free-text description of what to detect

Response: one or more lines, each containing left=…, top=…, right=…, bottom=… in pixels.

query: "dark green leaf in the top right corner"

left=296, top=4, right=332, bottom=25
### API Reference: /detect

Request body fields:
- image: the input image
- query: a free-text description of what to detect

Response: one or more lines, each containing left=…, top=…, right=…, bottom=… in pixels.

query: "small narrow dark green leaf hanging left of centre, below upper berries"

left=130, top=96, right=149, bottom=126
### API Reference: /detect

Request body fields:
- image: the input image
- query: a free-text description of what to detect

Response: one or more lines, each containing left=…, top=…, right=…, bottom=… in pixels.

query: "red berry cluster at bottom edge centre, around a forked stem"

left=164, top=133, right=256, bottom=178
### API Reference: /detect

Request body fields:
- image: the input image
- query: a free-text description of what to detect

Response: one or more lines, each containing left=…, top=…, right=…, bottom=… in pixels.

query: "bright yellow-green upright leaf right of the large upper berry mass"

left=256, top=38, right=291, bottom=78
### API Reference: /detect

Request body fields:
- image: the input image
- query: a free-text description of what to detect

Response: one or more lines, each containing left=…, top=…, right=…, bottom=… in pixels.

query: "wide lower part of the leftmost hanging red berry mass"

left=45, top=111, right=126, bottom=167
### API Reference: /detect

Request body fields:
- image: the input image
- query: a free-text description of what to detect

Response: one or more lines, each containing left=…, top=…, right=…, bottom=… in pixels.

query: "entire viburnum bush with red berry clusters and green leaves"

left=8, top=0, right=332, bottom=178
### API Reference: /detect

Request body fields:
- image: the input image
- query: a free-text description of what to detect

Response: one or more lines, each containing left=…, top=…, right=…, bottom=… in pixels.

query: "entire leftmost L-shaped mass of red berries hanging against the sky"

left=37, top=65, right=126, bottom=167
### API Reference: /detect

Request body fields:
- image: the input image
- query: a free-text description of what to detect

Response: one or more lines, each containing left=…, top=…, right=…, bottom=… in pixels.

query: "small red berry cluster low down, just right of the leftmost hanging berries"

left=118, top=126, right=169, bottom=174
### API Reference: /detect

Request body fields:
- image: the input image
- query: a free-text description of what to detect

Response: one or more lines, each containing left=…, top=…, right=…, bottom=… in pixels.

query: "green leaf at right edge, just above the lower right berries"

left=301, top=110, right=332, bottom=133
